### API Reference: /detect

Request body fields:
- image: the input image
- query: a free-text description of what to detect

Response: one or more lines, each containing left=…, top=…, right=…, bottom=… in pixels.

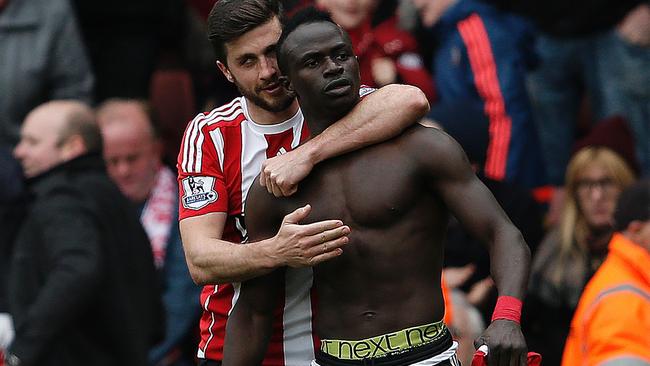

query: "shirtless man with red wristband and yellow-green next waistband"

left=224, top=9, right=530, bottom=366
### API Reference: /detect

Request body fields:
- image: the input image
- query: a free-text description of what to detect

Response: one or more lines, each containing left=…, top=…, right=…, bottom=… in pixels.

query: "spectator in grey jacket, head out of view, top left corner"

left=0, top=0, right=93, bottom=149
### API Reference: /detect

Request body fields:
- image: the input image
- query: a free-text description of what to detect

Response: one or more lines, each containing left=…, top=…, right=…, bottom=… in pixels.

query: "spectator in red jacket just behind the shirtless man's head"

left=315, top=0, right=435, bottom=101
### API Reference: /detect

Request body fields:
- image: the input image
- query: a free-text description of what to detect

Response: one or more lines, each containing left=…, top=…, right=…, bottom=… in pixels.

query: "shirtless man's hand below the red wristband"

left=474, top=319, right=528, bottom=366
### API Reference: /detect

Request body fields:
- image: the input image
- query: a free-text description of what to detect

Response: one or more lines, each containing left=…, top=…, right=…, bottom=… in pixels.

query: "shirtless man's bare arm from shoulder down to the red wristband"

left=410, top=127, right=530, bottom=299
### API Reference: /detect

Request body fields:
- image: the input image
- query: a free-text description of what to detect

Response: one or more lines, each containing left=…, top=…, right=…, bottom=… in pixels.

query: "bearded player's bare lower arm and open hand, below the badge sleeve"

left=180, top=187, right=350, bottom=285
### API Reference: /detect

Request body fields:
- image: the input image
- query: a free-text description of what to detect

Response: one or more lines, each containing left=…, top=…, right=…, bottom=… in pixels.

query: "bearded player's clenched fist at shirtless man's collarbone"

left=260, top=148, right=314, bottom=197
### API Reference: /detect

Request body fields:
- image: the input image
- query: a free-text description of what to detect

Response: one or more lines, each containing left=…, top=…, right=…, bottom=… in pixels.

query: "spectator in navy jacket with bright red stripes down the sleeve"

left=412, top=0, right=545, bottom=188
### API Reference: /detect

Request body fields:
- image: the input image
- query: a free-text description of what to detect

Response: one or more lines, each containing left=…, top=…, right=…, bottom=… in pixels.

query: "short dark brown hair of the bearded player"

left=208, top=0, right=282, bottom=65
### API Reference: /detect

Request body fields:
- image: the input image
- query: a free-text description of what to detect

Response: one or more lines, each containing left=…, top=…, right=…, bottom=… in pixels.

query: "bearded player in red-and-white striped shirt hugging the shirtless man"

left=178, top=0, right=428, bottom=365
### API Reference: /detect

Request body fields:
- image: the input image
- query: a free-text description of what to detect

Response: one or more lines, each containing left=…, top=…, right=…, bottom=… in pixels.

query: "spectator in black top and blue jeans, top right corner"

left=512, top=0, right=650, bottom=186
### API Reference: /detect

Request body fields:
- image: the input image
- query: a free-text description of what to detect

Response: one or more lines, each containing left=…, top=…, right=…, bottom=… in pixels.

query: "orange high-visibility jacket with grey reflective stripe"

left=562, top=233, right=650, bottom=366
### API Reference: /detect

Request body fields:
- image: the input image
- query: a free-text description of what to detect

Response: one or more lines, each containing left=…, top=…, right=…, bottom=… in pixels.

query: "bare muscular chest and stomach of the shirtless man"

left=248, top=126, right=448, bottom=339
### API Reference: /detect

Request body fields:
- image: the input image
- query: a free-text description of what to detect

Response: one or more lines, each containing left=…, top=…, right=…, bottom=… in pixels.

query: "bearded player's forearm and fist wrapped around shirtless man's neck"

left=260, top=84, right=429, bottom=197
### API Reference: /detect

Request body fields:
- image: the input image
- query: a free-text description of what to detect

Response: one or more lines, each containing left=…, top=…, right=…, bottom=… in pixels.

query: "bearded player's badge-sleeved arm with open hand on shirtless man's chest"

left=178, top=129, right=349, bottom=285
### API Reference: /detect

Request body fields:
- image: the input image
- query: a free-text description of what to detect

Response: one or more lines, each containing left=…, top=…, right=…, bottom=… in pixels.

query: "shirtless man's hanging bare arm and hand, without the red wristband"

left=406, top=126, right=530, bottom=366
